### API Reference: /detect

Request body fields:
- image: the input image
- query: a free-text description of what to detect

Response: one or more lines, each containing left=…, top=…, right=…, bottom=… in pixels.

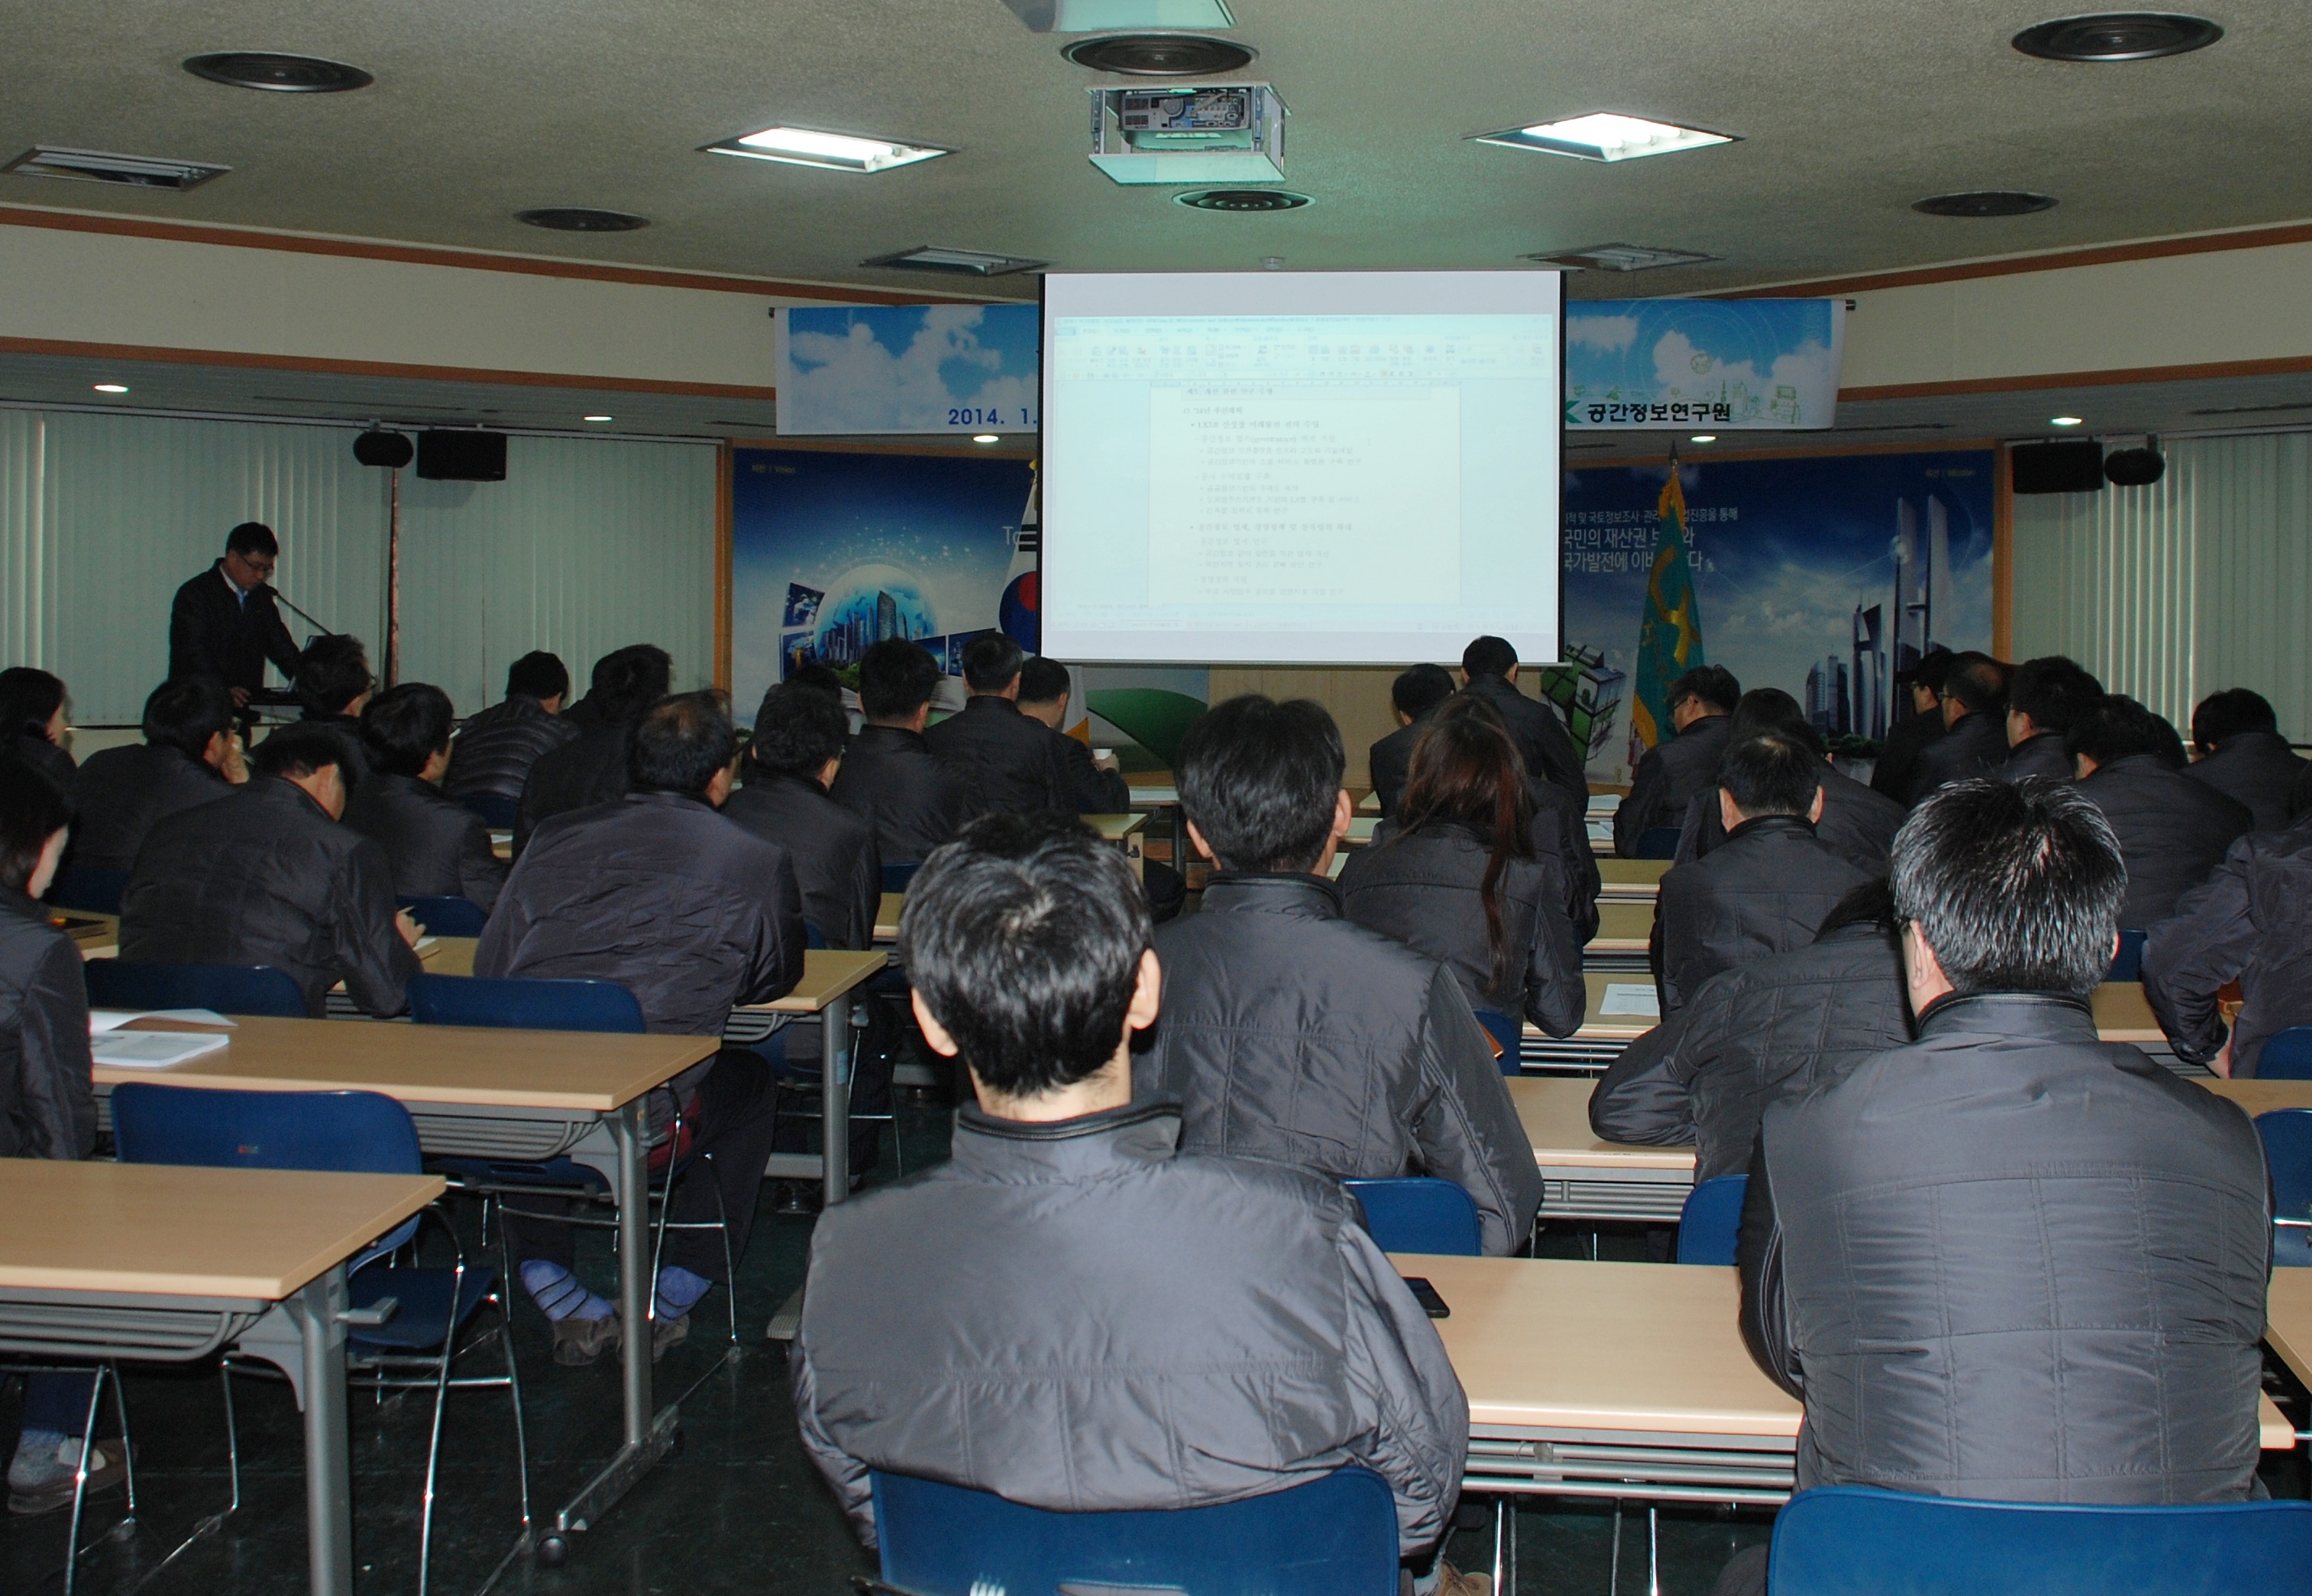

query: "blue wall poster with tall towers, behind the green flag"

left=1545, top=449, right=1993, bottom=782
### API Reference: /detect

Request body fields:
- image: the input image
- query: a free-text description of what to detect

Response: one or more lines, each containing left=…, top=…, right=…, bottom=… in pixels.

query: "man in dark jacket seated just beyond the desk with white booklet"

left=120, top=722, right=418, bottom=1020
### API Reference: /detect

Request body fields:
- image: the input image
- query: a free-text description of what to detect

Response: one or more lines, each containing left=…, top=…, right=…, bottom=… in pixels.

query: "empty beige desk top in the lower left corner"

left=0, top=1156, right=442, bottom=1303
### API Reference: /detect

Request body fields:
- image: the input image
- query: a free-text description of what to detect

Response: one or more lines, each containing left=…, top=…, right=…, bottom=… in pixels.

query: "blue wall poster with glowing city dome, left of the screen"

left=730, top=449, right=1038, bottom=724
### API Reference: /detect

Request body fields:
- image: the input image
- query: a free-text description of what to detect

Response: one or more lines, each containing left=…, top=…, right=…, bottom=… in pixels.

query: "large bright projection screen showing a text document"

left=1042, top=273, right=1563, bottom=664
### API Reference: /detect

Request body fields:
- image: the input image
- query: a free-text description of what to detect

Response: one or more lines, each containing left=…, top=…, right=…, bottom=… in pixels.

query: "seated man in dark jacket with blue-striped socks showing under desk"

left=474, top=691, right=802, bottom=1365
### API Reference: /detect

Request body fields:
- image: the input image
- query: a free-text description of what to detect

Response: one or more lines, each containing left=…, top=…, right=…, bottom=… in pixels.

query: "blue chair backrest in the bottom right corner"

left=1766, top=1485, right=2312, bottom=1596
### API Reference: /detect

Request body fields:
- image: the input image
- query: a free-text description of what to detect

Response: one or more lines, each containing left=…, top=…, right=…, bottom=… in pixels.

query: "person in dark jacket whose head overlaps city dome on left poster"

left=828, top=639, right=980, bottom=865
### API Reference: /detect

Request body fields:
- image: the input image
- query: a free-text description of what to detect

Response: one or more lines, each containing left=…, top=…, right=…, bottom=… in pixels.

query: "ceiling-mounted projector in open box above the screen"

left=1091, top=83, right=1290, bottom=183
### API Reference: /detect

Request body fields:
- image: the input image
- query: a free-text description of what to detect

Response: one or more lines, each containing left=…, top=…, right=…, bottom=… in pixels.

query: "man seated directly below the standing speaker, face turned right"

left=72, top=675, right=250, bottom=870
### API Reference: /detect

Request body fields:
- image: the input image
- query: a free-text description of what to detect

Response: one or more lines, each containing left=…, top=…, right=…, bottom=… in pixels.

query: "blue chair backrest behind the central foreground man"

left=874, top=1469, right=1397, bottom=1596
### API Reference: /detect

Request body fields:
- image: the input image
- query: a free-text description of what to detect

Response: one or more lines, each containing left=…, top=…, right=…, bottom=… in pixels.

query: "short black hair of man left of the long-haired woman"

left=1174, top=694, right=1348, bottom=872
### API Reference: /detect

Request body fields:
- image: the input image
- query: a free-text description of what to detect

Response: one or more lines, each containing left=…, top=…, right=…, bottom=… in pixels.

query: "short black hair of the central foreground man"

left=899, top=814, right=1152, bottom=1096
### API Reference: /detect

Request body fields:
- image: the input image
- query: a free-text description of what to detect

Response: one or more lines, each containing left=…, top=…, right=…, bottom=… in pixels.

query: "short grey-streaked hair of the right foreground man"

left=1889, top=777, right=2127, bottom=997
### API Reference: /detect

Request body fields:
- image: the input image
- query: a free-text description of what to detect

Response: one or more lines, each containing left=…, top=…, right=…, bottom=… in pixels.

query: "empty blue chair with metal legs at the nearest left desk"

left=113, top=1080, right=530, bottom=1591
